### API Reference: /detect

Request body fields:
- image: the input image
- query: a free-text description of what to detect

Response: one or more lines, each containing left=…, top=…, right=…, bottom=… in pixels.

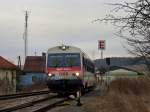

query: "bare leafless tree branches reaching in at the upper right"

left=95, top=0, right=150, bottom=71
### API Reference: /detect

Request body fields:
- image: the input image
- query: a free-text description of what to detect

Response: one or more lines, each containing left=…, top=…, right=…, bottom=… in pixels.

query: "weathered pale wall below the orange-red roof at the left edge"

left=0, top=69, right=17, bottom=95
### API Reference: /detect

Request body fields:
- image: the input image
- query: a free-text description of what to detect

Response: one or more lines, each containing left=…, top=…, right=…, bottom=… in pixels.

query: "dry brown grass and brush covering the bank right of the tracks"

left=84, top=78, right=150, bottom=112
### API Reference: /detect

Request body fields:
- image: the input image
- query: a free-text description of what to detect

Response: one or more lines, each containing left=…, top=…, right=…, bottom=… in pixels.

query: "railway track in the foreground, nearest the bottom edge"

left=0, top=95, right=70, bottom=112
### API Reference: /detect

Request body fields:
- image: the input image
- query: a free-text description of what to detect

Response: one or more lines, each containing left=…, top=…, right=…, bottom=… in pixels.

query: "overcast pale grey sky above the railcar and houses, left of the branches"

left=0, top=0, right=129, bottom=63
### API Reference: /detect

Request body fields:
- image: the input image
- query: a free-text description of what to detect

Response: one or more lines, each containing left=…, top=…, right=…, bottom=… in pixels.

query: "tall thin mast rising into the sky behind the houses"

left=23, top=11, right=29, bottom=59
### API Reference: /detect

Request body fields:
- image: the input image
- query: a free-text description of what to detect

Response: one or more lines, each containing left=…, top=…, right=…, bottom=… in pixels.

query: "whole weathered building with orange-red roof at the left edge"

left=0, top=56, right=19, bottom=95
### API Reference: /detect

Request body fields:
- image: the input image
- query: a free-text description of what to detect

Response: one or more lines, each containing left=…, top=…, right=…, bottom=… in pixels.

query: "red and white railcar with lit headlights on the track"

left=46, top=45, right=96, bottom=94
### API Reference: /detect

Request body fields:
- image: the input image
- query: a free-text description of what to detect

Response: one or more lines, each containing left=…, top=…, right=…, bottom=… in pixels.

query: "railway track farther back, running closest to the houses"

left=0, top=91, right=49, bottom=100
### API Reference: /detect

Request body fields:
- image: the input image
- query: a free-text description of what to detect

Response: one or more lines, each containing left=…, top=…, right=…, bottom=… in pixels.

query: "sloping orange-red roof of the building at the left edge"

left=0, top=56, right=18, bottom=69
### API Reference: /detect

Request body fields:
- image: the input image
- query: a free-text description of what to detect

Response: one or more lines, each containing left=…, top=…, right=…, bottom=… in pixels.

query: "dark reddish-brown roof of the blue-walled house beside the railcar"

left=24, top=56, right=46, bottom=73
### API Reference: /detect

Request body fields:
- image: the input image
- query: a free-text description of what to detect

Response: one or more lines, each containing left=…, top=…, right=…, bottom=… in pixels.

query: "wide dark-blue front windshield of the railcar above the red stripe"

left=47, top=53, right=81, bottom=67
